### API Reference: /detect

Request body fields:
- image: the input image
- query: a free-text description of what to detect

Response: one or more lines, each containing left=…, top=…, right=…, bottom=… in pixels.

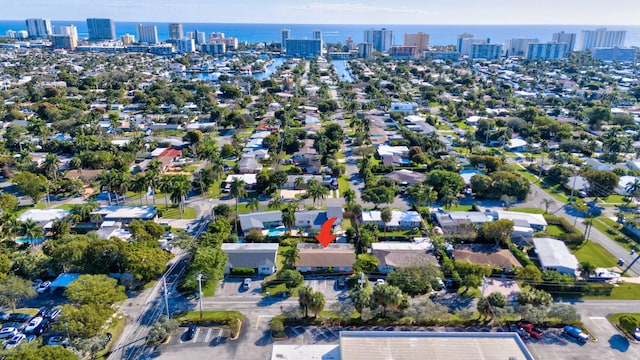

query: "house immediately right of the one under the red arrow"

left=371, top=241, right=438, bottom=273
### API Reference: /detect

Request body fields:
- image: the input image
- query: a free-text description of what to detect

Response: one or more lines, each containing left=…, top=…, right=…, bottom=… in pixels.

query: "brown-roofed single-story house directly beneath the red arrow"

left=296, top=243, right=356, bottom=272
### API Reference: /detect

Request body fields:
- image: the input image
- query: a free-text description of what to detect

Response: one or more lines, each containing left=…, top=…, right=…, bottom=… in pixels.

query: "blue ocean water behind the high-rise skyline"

left=0, top=20, right=640, bottom=46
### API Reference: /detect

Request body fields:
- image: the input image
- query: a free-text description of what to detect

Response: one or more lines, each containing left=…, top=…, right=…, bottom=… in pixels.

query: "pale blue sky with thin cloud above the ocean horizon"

left=0, top=0, right=640, bottom=25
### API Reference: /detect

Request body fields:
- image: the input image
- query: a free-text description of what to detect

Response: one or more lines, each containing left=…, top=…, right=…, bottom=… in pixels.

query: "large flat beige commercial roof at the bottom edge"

left=338, top=331, right=534, bottom=360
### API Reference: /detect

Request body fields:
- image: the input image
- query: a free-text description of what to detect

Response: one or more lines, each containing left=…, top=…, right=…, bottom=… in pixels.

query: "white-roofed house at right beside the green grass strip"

left=533, top=238, right=578, bottom=276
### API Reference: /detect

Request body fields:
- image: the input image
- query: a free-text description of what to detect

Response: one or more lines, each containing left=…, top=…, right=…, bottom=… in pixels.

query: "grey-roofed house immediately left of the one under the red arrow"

left=221, top=243, right=278, bottom=275
